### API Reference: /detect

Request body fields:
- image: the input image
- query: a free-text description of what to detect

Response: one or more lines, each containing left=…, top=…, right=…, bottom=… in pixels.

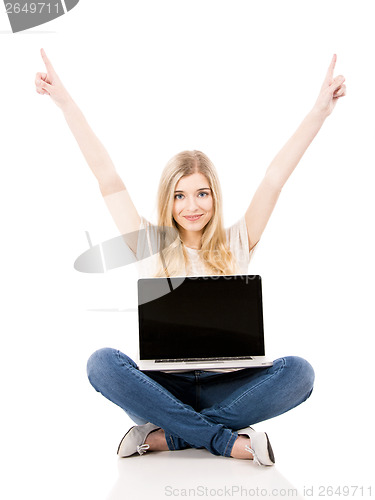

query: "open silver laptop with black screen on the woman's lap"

left=138, top=275, right=272, bottom=370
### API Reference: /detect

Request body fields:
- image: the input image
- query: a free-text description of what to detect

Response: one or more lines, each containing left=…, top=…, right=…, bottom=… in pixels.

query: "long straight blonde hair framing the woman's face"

left=155, top=150, right=238, bottom=277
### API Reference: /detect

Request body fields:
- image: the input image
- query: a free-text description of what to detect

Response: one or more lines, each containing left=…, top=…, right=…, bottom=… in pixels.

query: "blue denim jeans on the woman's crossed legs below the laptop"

left=87, top=348, right=314, bottom=457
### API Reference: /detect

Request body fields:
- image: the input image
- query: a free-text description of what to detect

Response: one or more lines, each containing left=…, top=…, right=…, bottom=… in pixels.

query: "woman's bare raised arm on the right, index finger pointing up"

left=245, top=54, right=346, bottom=249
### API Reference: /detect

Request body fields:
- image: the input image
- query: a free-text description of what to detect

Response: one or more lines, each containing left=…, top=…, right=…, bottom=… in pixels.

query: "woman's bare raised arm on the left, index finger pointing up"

left=35, top=49, right=141, bottom=243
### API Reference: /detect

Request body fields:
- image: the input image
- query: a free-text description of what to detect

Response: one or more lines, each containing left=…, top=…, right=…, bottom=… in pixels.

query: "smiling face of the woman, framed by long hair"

left=172, top=172, right=214, bottom=231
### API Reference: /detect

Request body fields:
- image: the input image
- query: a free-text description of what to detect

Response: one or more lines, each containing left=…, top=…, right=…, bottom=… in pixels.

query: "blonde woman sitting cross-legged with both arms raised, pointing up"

left=35, top=49, right=346, bottom=465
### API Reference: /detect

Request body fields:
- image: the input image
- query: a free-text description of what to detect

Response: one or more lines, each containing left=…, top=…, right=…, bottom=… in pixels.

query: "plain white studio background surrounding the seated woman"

left=0, top=0, right=375, bottom=499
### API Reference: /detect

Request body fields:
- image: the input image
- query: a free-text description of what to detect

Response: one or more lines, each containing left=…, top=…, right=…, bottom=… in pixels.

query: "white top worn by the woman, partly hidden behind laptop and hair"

left=136, top=216, right=258, bottom=373
